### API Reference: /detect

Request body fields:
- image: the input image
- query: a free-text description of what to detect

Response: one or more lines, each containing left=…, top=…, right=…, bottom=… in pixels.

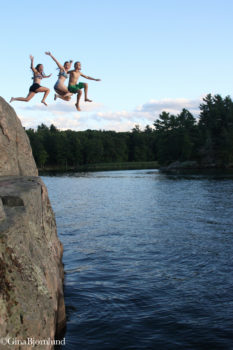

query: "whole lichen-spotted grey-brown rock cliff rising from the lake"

left=0, top=98, right=66, bottom=350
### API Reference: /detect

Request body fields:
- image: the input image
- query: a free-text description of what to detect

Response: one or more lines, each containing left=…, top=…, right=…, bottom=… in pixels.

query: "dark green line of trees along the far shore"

left=26, top=94, right=233, bottom=168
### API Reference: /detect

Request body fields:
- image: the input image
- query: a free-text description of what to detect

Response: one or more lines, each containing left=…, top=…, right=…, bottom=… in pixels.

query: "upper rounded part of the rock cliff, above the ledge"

left=0, top=97, right=38, bottom=176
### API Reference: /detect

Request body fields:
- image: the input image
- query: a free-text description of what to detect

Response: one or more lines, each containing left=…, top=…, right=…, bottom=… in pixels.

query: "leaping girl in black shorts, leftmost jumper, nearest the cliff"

left=10, top=56, right=52, bottom=106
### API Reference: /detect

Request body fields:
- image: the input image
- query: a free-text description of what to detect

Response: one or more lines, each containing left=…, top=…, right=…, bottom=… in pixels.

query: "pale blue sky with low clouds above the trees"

left=0, top=0, right=233, bottom=131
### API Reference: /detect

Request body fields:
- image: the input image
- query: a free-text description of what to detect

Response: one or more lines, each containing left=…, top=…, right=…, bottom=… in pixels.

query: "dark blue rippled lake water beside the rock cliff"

left=43, top=170, right=233, bottom=350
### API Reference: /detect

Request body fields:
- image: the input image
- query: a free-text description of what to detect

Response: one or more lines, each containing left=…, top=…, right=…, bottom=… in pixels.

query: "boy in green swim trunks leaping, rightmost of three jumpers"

left=68, top=62, right=100, bottom=111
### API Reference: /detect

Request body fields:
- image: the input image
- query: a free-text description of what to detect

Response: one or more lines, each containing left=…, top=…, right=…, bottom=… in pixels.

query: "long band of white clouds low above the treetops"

left=20, top=97, right=202, bottom=131
